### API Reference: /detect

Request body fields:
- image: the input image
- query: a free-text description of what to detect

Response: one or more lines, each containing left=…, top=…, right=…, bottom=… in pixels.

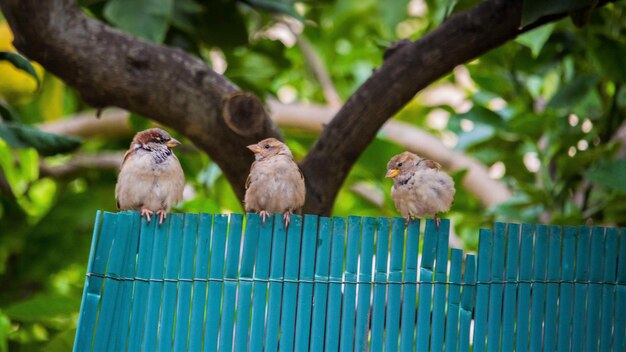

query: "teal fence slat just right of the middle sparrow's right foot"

left=280, top=216, right=302, bottom=351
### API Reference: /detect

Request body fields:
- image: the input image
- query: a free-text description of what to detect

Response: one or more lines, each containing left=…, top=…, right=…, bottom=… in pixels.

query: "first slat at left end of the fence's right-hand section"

left=473, top=229, right=493, bottom=351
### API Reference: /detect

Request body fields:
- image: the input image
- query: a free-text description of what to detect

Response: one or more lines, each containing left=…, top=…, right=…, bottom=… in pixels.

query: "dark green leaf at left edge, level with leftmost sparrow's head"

left=0, top=122, right=82, bottom=156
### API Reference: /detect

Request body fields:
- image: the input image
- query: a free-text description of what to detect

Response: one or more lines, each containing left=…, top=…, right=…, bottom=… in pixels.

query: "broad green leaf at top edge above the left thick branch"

left=104, top=0, right=174, bottom=43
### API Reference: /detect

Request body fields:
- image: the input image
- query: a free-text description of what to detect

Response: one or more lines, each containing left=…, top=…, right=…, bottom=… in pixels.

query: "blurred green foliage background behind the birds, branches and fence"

left=0, top=0, right=626, bottom=351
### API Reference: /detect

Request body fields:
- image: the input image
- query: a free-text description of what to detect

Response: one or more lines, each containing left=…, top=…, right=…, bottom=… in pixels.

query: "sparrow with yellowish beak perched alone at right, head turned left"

left=385, top=152, right=456, bottom=227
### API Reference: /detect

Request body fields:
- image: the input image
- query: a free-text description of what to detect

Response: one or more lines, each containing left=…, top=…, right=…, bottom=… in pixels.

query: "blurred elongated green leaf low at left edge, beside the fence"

left=5, top=295, right=80, bottom=322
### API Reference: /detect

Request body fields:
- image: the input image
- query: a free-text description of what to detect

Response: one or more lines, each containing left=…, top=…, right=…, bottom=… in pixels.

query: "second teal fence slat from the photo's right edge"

left=600, top=228, right=624, bottom=351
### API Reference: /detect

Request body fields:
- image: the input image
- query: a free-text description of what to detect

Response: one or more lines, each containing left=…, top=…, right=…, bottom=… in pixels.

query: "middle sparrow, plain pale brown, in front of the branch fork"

left=244, top=138, right=305, bottom=226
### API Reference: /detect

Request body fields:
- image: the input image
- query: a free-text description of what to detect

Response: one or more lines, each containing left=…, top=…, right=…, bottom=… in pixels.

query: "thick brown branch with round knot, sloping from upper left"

left=0, top=0, right=280, bottom=199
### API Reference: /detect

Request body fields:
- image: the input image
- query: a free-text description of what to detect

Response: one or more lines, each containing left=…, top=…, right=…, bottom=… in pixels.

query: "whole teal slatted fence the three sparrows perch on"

left=74, top=212, right=626, bottom=351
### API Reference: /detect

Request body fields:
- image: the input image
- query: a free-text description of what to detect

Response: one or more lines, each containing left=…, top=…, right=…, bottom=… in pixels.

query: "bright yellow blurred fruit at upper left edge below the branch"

left=0, top=22, right=43, bottom=104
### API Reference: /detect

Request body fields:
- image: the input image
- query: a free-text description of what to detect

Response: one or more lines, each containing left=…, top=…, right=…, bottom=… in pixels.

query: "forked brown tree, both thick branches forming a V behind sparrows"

left=0, top=0, right=596, bottom=215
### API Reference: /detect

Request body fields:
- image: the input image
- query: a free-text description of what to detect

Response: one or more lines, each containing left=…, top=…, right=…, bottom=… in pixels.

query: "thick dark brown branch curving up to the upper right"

left=302, top=0, right=576, bottom=214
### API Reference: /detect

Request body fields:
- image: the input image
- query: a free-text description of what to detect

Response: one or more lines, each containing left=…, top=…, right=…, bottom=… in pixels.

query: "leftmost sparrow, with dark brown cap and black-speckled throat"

left=115, top=128, right=185, bottom=224
